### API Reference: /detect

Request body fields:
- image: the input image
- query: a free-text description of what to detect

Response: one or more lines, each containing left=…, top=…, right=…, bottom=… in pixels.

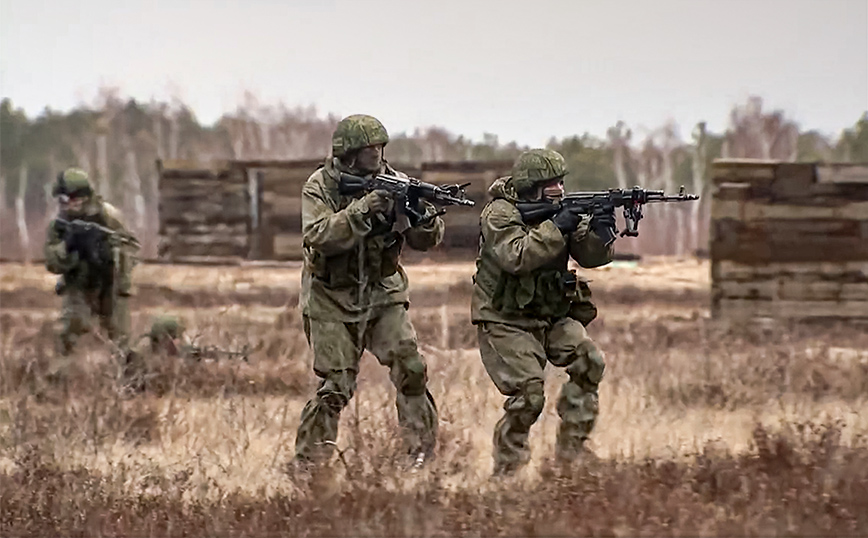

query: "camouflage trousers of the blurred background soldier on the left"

left=57, top=287, right=130, bottom=355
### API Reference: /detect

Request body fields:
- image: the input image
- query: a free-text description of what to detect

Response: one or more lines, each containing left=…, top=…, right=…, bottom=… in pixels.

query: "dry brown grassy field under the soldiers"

left=0, top=259, right=868, bottom=536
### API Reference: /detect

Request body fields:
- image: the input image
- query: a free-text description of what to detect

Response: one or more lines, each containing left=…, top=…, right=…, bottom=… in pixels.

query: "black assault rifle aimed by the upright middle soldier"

left=338, top=174, right=476, bottom=226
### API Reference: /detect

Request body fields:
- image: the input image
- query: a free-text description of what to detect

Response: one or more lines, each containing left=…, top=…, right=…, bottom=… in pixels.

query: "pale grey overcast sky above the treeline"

left=0, top=0, right=868, bottom=145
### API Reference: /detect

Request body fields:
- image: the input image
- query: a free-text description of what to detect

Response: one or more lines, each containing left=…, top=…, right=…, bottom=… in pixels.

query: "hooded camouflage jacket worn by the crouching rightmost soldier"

left=471, top=178, right=613, bottom=328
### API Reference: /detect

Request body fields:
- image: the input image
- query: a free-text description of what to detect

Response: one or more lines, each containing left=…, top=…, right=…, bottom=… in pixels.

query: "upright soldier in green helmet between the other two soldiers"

left=295, top=114, right=444, bottom=466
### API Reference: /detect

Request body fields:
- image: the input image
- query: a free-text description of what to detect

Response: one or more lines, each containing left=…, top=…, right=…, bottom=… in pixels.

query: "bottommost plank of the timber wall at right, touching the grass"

left=712, top=299, right=868, bottom=320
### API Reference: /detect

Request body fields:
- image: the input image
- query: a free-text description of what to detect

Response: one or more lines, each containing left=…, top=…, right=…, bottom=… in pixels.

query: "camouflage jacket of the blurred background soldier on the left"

left=44, top=196, right=137, bottom=295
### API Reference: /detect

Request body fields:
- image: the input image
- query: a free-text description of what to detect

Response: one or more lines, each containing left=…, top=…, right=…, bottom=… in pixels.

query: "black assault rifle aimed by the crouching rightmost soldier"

left=516, top=185, right=699, bottom=245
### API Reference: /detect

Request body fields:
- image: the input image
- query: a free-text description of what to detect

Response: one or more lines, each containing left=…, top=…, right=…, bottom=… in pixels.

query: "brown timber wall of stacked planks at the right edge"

left=710, top=160, right=868, bottom=321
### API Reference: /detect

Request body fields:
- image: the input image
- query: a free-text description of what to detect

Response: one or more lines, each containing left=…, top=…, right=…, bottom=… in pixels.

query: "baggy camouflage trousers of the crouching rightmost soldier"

left=477, top=318, right=605, bottom=474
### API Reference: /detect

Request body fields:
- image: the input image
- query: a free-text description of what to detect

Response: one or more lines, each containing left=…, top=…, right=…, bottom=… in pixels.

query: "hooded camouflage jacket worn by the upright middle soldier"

left=299, top=157, right=444, bottom=322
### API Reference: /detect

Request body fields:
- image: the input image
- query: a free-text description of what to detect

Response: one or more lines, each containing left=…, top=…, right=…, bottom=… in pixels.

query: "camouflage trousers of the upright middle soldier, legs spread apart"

left=295, top=305, right=437, bottom=461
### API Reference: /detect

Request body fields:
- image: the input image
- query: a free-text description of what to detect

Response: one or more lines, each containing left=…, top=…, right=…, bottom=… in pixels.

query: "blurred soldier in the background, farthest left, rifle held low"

left=45, top=168, right=137, bottom=356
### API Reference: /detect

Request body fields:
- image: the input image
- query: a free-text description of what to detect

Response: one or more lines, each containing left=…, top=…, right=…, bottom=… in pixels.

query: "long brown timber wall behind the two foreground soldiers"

left=157, top=159, right=512, bottom=263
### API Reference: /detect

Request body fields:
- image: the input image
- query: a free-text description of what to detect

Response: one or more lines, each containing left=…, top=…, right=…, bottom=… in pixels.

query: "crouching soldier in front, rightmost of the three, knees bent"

left=471, top=149, right=615, bottom=476
